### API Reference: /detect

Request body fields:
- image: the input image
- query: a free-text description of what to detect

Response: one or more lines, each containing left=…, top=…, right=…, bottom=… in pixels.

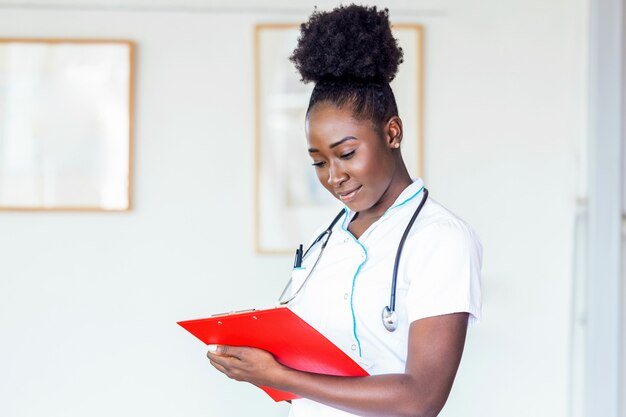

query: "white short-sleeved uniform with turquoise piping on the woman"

left=289, top=179, right=482, bottom=417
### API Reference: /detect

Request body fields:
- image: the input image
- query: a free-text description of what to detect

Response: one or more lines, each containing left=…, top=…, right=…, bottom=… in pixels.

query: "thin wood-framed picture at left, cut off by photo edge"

left=0, top=39, right=133, bottom=211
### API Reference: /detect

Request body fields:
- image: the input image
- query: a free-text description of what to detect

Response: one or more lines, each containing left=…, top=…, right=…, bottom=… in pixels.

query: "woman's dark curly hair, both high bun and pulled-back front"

left=289, top=4, right=402, bottom=126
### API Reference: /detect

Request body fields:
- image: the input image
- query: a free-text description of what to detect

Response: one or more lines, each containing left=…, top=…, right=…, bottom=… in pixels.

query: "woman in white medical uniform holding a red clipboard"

left=207, top=5, right=481, bottom=417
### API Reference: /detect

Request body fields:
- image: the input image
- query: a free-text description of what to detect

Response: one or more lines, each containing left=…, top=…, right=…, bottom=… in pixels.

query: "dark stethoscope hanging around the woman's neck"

left=278, top=188, right=428, bottom=332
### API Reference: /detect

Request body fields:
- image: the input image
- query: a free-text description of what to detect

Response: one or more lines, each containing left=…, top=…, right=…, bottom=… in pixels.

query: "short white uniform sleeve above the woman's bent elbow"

left=404, top=220, right=482, bottom=325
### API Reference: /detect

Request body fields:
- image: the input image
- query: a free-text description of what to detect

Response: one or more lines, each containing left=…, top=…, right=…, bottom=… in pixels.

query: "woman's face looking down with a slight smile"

left=306, top=103, right=402, bottom=212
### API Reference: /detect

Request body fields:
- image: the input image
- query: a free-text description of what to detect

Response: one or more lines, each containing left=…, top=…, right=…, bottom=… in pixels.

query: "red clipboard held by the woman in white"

left=178, top=307, right=369, bottom=401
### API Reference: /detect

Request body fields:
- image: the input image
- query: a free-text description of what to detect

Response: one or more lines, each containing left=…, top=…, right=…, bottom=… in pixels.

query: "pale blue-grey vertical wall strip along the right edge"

left=585, top=0, right=626, bottom=417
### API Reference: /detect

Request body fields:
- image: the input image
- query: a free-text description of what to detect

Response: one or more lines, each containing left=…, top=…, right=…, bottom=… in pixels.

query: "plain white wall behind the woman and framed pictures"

left=0, top=0, right=587, bottom=417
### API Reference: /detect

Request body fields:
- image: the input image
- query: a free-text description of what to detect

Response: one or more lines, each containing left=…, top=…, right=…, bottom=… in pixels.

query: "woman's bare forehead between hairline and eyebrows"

left=305, top=103, right=377, bottom=141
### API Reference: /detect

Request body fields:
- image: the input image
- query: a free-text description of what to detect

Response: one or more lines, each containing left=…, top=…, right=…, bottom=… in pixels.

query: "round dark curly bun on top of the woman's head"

left=289, top=4, right=402, bottom=83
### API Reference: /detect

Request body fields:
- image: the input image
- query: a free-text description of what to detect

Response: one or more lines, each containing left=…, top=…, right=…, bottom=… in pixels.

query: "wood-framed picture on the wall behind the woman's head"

left=255, top=24, right=423, bottom=254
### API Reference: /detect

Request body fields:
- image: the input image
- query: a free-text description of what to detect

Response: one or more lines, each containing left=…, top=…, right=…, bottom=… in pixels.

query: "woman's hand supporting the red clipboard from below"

left=207, top=345, right=287, bottom=387
